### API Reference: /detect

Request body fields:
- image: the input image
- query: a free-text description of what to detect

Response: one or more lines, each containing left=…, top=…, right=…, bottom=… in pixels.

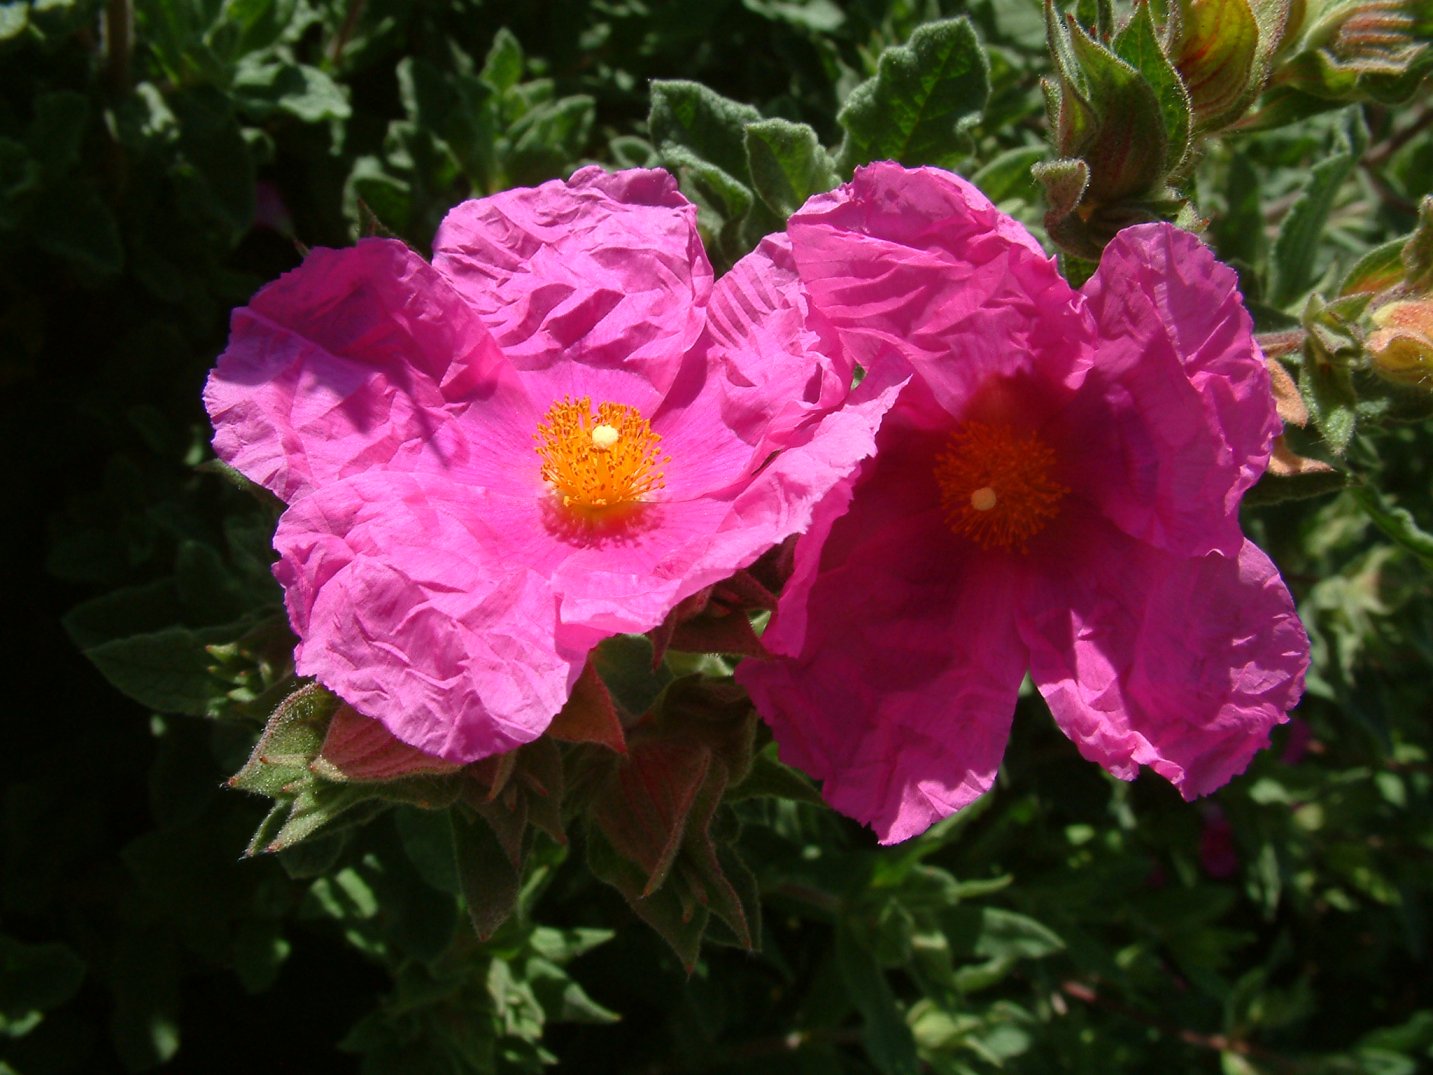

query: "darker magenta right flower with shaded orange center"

left=738, top=163, right=1308, bottom=843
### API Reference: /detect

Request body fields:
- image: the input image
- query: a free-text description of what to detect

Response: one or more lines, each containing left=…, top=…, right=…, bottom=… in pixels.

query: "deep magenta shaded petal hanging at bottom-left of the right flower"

left=737, top=415, right=1026, bottom=843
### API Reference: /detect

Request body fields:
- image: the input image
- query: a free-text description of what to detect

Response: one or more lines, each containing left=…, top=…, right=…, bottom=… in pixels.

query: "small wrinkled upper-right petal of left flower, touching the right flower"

left=706, top=235, right=854, bottom=450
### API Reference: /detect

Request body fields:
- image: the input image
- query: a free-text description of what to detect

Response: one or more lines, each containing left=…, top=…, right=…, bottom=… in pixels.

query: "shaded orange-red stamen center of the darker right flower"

left=936, top=421, right=1069, bottom=552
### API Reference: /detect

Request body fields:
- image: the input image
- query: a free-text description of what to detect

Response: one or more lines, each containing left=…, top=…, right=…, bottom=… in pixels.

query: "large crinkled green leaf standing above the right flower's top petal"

left=837, top=19, right=990, bottom=173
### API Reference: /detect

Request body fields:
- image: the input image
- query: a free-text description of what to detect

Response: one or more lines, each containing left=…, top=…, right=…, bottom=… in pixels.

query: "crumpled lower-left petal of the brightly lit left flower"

left=274, top=470, right=584, bottom=763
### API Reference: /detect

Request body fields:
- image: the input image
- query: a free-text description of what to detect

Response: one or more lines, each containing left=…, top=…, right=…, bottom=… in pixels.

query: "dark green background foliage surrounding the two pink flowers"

left=0, top=0, right=1433, bottom=1075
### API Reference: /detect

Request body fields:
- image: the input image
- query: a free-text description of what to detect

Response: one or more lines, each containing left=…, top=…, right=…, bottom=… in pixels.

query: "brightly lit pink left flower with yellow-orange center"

left=205, top=168, right=894, bottom=761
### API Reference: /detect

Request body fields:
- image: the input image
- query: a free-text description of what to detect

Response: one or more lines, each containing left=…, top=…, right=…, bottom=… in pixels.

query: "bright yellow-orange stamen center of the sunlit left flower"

left=533, top=396, right=671, bottom=515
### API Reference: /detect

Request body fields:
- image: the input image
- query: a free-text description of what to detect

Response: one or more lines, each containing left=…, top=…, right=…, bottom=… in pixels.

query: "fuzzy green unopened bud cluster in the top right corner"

left=1035, top=0, right=1433, bottom=259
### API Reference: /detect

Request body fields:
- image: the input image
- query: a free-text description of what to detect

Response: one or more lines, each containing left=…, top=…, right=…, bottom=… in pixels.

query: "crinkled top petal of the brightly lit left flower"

left=433, top=168, right=712, bottom=413
